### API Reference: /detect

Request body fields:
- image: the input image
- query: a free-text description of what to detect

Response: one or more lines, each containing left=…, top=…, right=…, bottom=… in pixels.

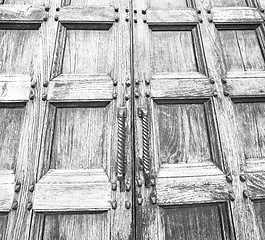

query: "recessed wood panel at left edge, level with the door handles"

left=0, top=106, right=25, bottom=170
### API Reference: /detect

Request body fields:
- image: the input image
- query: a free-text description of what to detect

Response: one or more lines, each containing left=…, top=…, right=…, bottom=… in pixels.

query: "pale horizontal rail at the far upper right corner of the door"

left=212, top=7, right=263, bottom=25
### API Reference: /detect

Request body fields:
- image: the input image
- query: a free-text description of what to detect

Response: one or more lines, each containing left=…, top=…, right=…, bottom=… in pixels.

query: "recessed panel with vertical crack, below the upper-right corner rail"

left=219, top=30, right=265, bottom=72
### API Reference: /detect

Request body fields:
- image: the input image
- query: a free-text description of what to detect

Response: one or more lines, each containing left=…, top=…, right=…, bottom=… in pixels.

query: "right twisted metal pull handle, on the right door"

left=138, top=107, right=150, bottom=186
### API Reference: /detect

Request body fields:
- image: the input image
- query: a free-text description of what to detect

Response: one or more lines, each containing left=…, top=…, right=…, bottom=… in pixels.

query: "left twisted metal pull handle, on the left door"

left=117, top=108, right=126, bottom=180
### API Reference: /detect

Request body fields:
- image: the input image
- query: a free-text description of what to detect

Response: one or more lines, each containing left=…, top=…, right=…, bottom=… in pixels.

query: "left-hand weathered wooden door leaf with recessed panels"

left=0, top=0, right=132, bottom=240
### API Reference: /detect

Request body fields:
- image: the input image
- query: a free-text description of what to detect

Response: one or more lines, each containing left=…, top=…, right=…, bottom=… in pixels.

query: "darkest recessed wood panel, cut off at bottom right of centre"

left=164, top=205, right=230, bottom=240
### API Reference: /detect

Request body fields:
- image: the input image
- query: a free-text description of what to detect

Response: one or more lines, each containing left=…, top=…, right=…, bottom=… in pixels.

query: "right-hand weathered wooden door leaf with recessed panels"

left=133, top=0, right=265, bottom=240
